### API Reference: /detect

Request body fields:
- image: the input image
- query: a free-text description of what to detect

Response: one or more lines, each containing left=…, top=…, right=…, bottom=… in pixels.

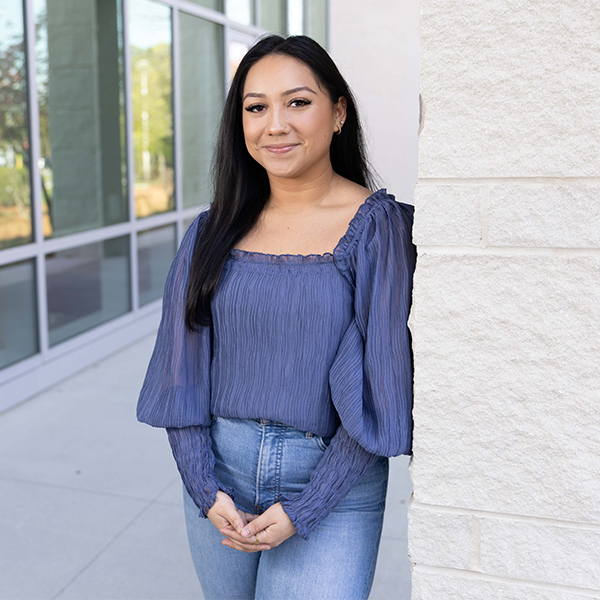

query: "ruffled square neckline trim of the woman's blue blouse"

left=230, top=188, right=389, bottom=264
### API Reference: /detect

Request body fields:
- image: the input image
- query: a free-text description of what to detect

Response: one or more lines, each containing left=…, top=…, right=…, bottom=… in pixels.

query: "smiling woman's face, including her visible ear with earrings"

left=242, top=54, right=346, bottom=180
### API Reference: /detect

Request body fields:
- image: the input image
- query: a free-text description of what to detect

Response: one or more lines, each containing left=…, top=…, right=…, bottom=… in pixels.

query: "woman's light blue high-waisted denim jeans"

left=184, top=417, right=389, bottom=600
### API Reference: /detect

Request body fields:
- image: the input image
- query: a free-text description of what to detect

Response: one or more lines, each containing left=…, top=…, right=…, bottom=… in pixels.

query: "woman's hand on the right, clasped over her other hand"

left=219, top=502, right=296, bottom=552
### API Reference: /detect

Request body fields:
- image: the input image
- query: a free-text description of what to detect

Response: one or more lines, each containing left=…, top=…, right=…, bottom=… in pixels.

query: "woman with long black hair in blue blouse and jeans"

left=138, top=36, right=415, bottom=600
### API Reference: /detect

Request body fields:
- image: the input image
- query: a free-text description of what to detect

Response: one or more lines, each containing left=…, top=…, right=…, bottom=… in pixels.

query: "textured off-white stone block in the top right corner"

left=419, top=0, right=600, bottom=178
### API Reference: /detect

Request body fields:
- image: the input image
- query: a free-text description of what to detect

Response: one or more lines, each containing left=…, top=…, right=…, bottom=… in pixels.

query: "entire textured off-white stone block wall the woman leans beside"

left=409, top=0, right=600, bottom=600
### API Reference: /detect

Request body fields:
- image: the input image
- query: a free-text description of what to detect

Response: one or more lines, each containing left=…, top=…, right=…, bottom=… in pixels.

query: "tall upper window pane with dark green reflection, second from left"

left=33, top=0, right=128, bottom=237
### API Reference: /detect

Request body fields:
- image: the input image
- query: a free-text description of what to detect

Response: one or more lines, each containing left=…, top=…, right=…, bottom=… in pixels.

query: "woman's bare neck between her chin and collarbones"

left=267, top=165, right=339, bottom=212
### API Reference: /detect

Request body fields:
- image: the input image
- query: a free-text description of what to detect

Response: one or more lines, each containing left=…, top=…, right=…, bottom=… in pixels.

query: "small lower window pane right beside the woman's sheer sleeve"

left=138, top=225, right=176, bottom=306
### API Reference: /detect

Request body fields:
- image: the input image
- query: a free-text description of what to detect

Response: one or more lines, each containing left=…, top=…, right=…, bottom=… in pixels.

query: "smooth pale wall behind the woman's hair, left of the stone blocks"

left=329, top=0, right=419, bottom=204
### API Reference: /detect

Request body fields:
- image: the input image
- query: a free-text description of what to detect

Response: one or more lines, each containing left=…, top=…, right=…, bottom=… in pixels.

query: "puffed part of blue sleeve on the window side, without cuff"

left=137, top=211, right=211, bottom=427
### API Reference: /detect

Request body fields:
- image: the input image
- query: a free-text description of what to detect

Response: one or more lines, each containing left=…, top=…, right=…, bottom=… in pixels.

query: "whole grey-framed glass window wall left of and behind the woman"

left=0, top=0, right=327, bottom=402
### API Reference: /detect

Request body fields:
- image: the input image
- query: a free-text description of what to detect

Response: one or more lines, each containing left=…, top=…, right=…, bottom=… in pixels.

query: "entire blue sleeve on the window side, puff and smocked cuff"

left=137, top=211, right=233, bottom=517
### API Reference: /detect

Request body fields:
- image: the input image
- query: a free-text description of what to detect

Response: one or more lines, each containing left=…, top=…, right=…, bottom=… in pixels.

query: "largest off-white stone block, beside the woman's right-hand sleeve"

left=409, top=253, right=600, bottom=523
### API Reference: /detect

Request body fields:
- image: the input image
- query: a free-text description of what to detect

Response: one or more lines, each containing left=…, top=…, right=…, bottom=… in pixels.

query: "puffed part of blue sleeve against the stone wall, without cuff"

left=329, top=200, right=416, bottom=457
